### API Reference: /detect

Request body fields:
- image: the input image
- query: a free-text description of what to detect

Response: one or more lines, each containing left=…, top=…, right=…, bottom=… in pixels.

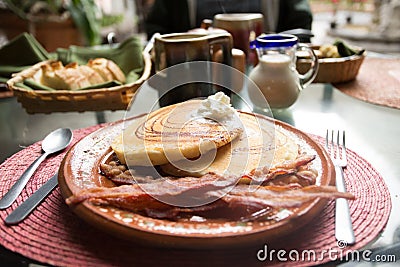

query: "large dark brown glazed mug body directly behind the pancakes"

left=153, top=32, right=232, bottom=106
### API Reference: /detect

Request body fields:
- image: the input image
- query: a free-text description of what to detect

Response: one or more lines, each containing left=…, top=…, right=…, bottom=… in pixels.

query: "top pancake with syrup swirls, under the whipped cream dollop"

left=111, top=97, right=243, bottom=166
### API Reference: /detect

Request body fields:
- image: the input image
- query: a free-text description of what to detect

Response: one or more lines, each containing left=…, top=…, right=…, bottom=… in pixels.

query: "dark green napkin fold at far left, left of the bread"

left=0, top=33, right=51, bottom=82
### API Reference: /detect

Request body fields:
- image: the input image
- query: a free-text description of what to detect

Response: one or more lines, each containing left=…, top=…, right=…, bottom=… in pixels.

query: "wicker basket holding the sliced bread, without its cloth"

left=7, top=52, right=151, bottom=114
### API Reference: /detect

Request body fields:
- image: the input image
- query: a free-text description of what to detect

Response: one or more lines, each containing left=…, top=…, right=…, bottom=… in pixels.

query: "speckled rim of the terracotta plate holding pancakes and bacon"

left=59, top=112, right=334, bottom=248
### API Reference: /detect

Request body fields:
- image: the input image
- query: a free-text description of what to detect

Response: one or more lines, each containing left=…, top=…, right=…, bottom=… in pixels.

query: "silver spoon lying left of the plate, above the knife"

left=0, top=128, right=72, bottom=209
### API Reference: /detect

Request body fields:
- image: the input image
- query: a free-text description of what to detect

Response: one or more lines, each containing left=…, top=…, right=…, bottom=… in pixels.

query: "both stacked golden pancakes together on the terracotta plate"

left=111, top=93, right=299, bottom=177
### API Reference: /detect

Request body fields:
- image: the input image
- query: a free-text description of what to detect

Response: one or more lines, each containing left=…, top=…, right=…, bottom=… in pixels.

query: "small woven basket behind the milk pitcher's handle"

left=296, top=55, right=365, bottom=83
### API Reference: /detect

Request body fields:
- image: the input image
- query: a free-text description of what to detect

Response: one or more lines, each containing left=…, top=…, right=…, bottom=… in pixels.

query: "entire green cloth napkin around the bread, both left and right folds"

left=0, top=33, right=144, bottom=90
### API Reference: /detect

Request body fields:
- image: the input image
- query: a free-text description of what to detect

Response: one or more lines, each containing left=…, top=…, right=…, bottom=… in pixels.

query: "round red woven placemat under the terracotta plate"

left=0, top=126, right=391, bottom=266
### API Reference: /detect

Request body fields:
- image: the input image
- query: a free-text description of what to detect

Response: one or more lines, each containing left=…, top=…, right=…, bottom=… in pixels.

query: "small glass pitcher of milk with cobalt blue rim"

left=248, top=34, right=318, bottom=109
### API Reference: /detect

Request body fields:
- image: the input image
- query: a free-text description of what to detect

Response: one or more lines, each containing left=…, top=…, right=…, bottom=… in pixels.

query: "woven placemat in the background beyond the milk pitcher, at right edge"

left=334, top=57, right=400, bottom=109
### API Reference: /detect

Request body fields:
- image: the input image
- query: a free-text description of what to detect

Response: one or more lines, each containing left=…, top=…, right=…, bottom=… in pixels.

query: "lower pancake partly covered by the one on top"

left=161, top=112, right=299, bottom=177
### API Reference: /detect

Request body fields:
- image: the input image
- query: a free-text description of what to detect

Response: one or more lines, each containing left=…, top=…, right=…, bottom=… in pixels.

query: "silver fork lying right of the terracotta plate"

left=325, top=130, right=356, bottom=245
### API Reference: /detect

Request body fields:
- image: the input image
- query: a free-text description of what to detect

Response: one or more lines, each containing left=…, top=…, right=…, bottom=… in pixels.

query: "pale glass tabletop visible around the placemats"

left=0, top=77, right=400, bottom=266
